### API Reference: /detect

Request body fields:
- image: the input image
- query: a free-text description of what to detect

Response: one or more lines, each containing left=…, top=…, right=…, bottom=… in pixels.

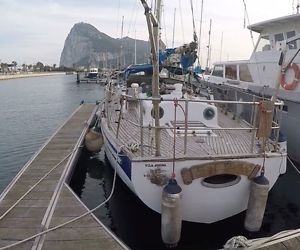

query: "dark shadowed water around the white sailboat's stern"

left=71, top=151, right=300, bottom=250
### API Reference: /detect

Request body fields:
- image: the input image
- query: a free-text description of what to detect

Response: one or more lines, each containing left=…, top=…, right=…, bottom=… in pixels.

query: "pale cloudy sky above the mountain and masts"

left=0, top=0, right=297, bottom=65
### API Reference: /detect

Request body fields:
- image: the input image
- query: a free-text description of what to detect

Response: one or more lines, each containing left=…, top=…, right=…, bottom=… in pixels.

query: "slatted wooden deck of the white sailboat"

left=106, top=94, right=270, bottom=160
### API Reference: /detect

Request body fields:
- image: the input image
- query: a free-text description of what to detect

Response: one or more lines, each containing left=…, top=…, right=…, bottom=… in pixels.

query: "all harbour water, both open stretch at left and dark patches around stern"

left=0, top=75, right=300, bottom=249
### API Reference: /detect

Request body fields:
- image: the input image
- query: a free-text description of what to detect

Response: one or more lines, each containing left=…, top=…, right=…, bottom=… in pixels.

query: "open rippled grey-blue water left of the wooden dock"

left=0, top=75, right=103, bottom=191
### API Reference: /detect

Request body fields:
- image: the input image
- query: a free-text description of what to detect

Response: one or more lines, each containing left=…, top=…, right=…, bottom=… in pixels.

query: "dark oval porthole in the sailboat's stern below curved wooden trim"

left=201, top=174, right=241, bottom=188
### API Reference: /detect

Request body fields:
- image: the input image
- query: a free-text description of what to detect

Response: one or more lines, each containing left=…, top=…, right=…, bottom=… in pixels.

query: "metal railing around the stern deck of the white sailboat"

left=106, top=85, right=284, bottom=157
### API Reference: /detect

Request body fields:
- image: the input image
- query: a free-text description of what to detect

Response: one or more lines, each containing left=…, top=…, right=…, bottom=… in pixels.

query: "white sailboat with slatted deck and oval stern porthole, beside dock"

left=100, top=0, right=286, bottom=243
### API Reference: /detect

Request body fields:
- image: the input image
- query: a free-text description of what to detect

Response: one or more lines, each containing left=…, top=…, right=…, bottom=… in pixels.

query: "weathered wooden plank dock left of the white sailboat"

left=0, top=104, right=127, bottom=250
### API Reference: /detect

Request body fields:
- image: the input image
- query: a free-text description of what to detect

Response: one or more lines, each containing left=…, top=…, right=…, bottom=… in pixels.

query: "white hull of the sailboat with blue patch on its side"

left=102, top=121, right=286, bottom=223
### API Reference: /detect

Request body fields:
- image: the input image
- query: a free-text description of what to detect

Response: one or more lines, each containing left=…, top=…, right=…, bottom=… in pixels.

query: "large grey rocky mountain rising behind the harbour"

left=60, top=23, right=150, bottom=68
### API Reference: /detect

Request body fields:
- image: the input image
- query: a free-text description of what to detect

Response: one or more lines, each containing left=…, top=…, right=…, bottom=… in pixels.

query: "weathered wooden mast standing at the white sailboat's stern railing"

left=141, top=0, right=161, bottom=156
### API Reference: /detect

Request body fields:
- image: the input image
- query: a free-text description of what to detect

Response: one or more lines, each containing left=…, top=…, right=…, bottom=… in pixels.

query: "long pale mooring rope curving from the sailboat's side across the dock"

left=0, top=146, right=123, bottom=250
